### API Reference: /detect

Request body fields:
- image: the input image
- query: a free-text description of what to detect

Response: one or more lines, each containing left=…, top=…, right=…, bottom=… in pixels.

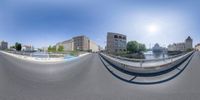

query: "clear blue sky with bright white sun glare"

left=0, top=0, right=200, bottom=48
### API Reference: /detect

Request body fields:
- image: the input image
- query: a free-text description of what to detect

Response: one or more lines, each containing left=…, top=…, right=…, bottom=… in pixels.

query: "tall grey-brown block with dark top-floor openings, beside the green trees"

left=106, top=32, right=126, bottom=53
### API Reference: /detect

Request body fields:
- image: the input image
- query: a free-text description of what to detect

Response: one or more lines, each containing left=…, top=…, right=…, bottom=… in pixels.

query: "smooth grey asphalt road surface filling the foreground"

left=0, top=52, right=200, bottom=100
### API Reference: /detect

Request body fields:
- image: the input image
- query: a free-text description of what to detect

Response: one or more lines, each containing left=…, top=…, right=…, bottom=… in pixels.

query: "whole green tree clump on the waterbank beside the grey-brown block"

left=127, top=41, right=146, bottom=53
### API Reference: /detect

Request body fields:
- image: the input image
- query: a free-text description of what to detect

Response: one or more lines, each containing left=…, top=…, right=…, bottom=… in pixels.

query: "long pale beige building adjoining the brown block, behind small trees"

left=56, top=39, right=74, bottom=51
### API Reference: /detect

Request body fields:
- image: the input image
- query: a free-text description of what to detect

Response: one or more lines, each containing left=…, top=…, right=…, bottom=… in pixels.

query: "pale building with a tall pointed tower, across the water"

left=168, top=36, right=193, bottom=51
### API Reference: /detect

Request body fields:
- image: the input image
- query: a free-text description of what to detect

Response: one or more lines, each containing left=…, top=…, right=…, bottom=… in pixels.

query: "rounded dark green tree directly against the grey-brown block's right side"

left=127, top=41, right=139, bottom=53
